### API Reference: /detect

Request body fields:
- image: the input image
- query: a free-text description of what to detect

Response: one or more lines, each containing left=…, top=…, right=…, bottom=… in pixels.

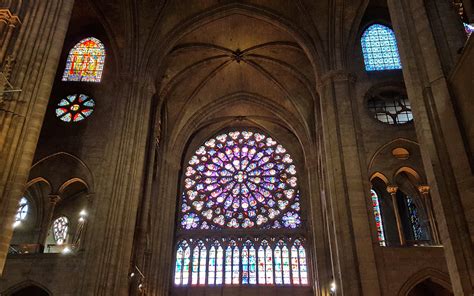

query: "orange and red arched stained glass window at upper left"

left=63, top=37, right=105, bottom=82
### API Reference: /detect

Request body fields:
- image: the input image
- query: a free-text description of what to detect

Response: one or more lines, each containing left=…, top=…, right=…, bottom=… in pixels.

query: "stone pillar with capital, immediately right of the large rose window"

left=319, top=71, right=381, bottom=296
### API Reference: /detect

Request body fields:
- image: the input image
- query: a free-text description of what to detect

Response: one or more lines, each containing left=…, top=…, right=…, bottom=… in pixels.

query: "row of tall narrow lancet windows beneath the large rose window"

left=174, top=238, right=309, bottom=286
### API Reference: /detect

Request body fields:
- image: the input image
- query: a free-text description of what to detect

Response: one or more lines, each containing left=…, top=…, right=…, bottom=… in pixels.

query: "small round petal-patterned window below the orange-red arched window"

left=56, top=94, right=95, bottom=122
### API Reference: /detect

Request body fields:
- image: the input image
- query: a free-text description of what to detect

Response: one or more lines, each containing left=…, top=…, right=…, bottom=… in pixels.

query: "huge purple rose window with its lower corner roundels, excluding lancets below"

left=181, top=131, right=301, bottom=229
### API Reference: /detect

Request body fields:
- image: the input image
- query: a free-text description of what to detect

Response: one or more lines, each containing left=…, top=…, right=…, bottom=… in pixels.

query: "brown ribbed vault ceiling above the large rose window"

left=159, top=13, right=317, bottom=147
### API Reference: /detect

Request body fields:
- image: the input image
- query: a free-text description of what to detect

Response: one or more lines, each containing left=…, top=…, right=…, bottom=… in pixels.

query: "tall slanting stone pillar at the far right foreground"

left=388, top=0, right=474, bottom=295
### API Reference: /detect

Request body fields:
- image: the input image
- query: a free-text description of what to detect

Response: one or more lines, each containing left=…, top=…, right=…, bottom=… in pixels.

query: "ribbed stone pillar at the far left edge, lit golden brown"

left=0, top=0, right=74, bottom=275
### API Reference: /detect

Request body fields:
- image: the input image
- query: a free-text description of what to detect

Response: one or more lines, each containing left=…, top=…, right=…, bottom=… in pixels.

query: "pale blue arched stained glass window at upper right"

left=361, top=24, right=402, bottom=71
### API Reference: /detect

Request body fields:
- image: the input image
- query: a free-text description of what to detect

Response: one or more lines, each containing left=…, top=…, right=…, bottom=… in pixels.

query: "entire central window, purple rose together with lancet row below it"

left=174, top=131, right=309, bottom=286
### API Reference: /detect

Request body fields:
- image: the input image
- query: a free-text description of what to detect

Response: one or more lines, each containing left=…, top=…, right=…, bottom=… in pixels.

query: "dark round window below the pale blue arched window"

left=367, top=88, right=413, bottom=125
